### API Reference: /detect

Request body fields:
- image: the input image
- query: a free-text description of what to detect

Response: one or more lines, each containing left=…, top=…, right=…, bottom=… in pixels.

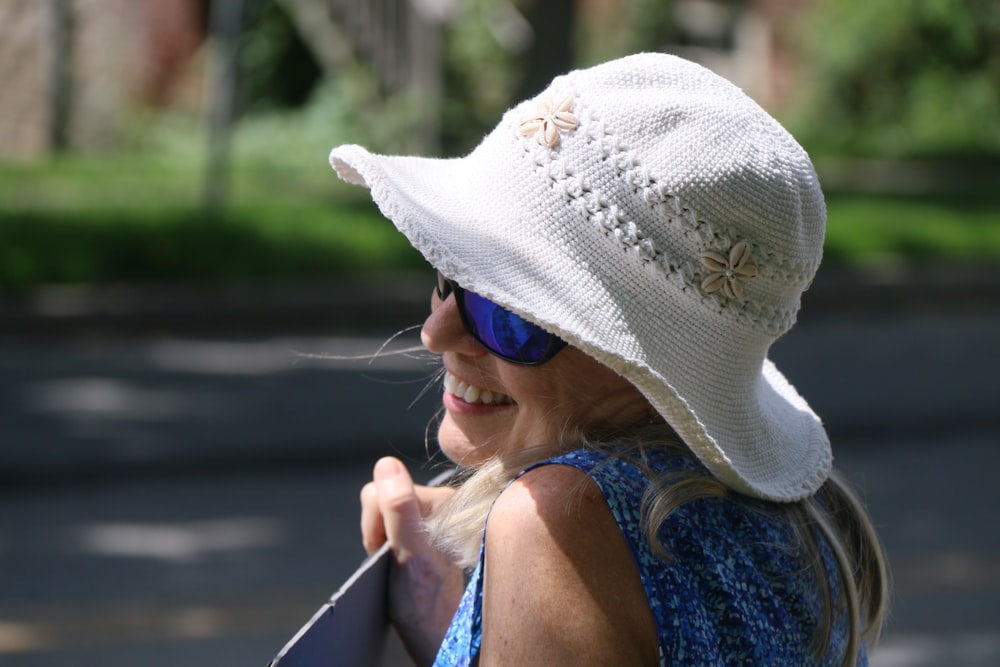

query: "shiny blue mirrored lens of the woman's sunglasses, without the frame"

left=460, top=290, right=554, bottom=364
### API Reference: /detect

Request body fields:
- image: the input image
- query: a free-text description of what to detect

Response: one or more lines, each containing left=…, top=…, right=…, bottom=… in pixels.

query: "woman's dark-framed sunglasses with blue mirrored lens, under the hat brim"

left=437, top=271, right=566, bottom=366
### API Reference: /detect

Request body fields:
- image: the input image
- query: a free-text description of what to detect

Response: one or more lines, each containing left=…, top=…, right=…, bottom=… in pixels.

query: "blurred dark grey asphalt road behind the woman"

left=0, top=306, right=1000, bottom=667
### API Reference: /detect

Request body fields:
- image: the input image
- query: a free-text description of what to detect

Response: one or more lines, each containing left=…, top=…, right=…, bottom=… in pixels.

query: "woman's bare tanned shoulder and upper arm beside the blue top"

left=483, top=465, right=658, bottom=664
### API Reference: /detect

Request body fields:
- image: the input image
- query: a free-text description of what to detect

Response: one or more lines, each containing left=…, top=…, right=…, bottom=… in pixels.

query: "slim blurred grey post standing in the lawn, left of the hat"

left=204, top=0, right=243, bottom=211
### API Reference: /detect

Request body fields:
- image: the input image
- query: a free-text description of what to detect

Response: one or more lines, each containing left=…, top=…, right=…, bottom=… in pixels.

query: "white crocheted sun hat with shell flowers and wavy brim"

left=330, top=54, right=831, bottom=501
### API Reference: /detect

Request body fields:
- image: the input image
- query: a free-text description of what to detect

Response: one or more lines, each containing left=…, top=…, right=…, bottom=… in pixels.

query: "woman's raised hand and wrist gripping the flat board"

left=361, top=457, right=465, bottom=665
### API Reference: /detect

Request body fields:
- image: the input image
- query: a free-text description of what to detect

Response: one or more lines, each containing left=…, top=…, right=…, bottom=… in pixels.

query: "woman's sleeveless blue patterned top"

left=435, top=450, right=868, bottom=667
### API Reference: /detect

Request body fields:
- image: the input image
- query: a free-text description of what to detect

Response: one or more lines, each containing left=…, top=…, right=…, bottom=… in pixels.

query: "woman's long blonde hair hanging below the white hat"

left=427, top=424, right=889, bottom=667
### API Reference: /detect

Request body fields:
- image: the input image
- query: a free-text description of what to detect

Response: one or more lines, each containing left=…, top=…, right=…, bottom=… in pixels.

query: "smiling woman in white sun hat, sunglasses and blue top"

left=330, top=54, right=886, bottom=666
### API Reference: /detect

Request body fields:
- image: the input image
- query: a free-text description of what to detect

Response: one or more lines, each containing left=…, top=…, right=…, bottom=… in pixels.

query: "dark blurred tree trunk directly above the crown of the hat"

left=516, top=0, right=576, bottom=100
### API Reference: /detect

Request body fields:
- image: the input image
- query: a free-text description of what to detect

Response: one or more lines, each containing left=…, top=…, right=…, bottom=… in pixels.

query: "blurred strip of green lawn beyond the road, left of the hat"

left=0, top=156, right=424, bottom=290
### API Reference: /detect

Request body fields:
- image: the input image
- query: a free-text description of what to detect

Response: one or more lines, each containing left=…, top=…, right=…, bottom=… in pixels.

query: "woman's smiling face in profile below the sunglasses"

left=421, top=284, right=649, bottom=467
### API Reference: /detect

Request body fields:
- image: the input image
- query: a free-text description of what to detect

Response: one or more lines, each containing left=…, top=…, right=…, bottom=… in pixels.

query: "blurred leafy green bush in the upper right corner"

left=789, top=0, right=1000, bottom=158
